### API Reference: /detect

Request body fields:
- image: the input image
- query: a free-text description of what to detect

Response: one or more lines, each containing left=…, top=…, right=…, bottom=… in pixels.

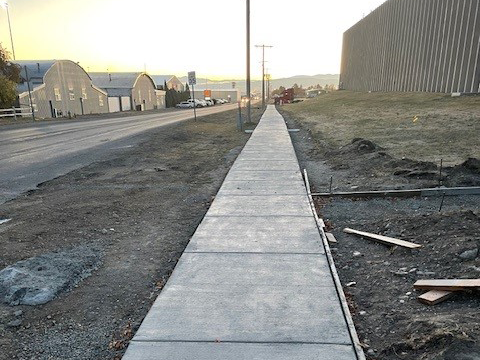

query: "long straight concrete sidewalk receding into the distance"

left=123, top=106, right=357, bottom=360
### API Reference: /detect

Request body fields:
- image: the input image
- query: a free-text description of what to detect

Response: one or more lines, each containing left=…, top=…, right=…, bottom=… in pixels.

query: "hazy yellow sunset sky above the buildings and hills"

left=0, top=0, right=384, bottom=79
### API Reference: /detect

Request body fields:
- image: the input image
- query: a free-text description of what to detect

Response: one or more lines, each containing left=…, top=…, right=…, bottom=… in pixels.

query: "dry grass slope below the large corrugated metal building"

left=283, top=91, right=480, bottom=165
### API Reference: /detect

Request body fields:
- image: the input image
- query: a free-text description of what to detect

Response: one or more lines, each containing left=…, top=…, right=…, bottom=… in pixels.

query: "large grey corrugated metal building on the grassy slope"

left=339, top=0, right=480, bottom=93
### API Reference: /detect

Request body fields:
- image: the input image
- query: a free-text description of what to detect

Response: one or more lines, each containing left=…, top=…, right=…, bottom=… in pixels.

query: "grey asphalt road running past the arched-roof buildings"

left=0, top=104, right=236, bottom=204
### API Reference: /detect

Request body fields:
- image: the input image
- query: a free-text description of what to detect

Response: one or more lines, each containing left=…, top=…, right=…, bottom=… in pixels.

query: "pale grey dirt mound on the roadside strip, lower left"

left=0, top=246, right=100, bottom=306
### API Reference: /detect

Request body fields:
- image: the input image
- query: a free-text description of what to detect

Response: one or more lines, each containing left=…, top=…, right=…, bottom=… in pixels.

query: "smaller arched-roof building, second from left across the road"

left=90, top=72, right=165, bottom=112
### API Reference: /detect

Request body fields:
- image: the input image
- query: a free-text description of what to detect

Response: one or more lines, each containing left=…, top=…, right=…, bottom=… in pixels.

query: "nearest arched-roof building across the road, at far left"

left=15, top=60, right=108, bottom=118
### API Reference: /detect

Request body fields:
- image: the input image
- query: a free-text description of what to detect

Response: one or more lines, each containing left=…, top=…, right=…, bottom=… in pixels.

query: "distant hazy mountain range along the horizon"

left=179, top=74, right=340, bottom=93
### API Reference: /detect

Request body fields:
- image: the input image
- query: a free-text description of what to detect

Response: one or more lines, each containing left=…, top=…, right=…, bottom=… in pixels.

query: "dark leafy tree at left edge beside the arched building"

left=0, top=44, right=21, bottom=108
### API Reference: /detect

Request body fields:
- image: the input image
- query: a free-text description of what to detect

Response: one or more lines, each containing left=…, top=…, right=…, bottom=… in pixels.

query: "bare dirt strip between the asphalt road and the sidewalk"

left=0, top=110, right=260, bottom=360
